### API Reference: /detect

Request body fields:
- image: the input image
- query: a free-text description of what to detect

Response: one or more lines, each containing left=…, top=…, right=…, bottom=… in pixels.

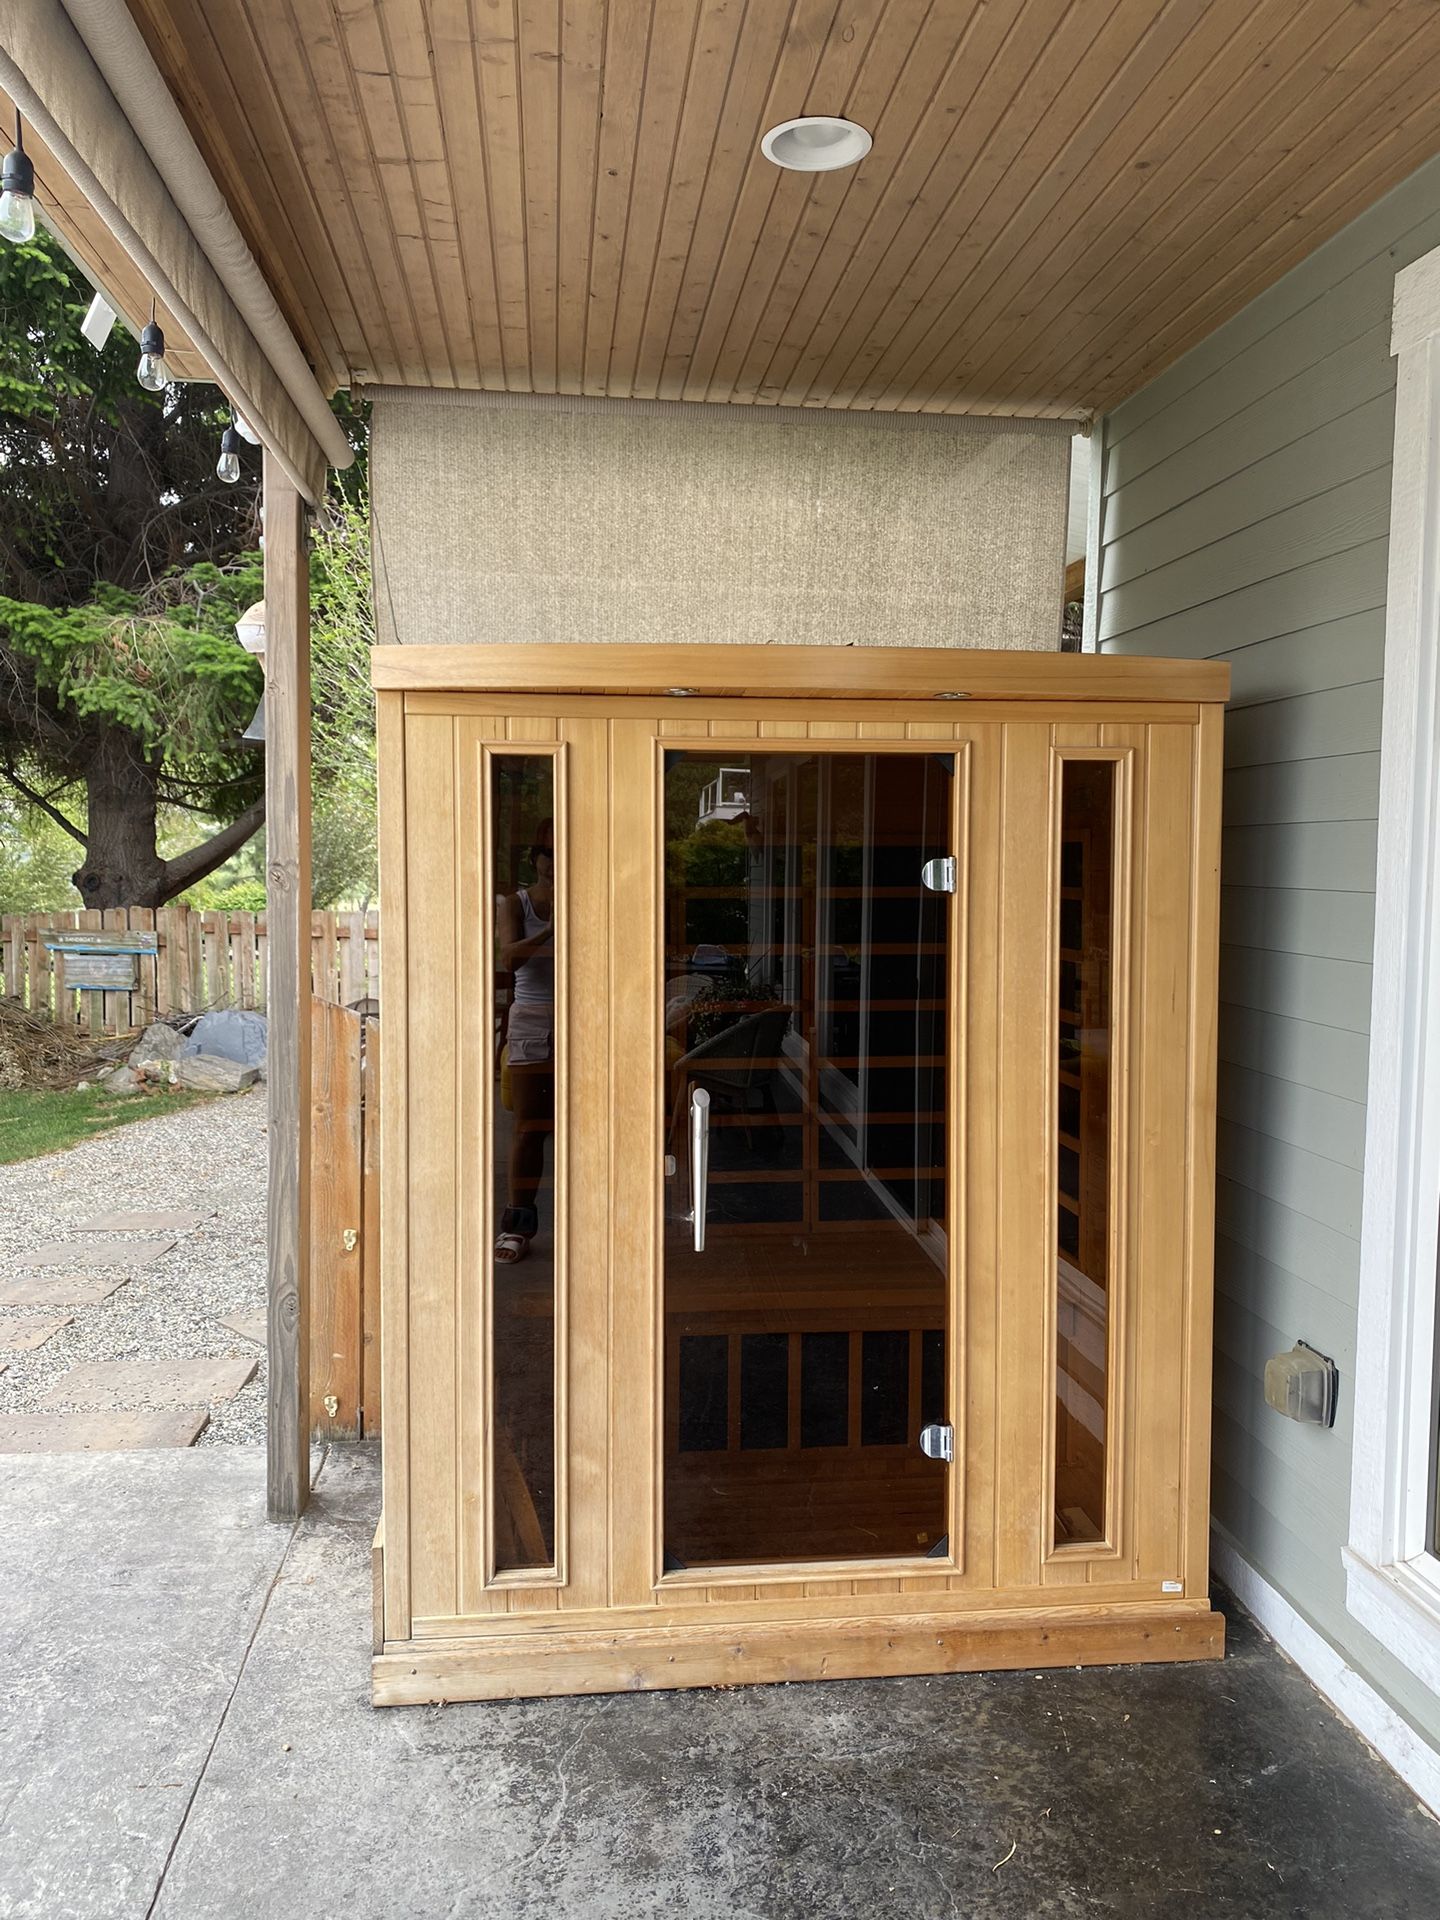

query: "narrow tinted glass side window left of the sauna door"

left=490, top=755, right=559, bottom=1572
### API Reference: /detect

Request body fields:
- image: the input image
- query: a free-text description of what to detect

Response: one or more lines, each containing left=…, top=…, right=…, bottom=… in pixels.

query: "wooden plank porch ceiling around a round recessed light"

left=115, top=0, right=1440, bottom=417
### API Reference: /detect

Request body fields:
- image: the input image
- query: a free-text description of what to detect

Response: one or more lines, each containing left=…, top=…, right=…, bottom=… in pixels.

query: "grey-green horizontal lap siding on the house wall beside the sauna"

left=1096, top=161, right=1440, bottom=1745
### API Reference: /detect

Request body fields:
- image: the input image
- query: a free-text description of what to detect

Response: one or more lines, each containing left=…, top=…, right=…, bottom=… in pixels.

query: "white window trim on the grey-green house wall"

left=1344, top=236, right=1440, bottom=1693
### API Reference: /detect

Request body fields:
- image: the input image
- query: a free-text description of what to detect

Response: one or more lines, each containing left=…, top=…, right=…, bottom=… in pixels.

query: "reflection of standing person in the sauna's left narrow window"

left=495, top=820, right=555, bottom=1265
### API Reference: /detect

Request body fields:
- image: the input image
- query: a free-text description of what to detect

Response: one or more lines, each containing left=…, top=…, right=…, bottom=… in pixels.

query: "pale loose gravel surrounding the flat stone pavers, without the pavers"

left=0, top=1089, right=265, bottom=1446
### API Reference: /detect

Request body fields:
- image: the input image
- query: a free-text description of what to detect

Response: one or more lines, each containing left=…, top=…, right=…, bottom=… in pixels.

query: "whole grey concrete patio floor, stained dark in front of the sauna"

left=0, top=1448, right=1440, bottom=1920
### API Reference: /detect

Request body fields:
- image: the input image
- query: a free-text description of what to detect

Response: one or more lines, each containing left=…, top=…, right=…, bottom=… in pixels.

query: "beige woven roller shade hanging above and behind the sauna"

left=371, top=388, right=1073, bottom=651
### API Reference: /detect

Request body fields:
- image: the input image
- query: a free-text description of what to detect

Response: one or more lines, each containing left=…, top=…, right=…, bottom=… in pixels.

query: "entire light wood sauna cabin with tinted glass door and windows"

left=374, top=645, right=1227, bottom=1703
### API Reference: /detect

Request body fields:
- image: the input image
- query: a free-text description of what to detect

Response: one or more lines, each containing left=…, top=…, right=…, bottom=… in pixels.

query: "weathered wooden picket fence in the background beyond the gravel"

left=0, top=906, right=380, bottom=1033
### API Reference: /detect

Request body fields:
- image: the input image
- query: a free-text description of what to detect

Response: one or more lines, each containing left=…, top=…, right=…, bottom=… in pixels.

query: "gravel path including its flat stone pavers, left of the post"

left=0, top=1092, right=265, bottom=1443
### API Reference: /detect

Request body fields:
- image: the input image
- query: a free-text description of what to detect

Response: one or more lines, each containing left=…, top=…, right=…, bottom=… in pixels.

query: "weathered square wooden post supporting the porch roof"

left=265, top=451, right=311, bottom=1521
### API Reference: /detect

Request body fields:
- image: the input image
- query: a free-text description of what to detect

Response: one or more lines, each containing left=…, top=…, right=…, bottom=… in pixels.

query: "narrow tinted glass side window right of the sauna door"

left=1054, top=760, right=1116, bottom=1546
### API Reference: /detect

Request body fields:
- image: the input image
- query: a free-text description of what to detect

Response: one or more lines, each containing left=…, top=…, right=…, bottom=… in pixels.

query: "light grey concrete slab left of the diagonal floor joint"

left=0, top=1448, right=288, bottom=1920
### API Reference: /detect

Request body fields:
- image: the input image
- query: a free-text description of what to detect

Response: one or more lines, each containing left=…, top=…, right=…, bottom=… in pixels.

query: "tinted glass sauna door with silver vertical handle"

left=662, top=751, right=954, bottom=1572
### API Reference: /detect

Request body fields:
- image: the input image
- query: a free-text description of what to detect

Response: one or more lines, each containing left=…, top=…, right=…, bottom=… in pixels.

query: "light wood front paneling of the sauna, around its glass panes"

left=380, top=695, right=1217, bottom=1674
